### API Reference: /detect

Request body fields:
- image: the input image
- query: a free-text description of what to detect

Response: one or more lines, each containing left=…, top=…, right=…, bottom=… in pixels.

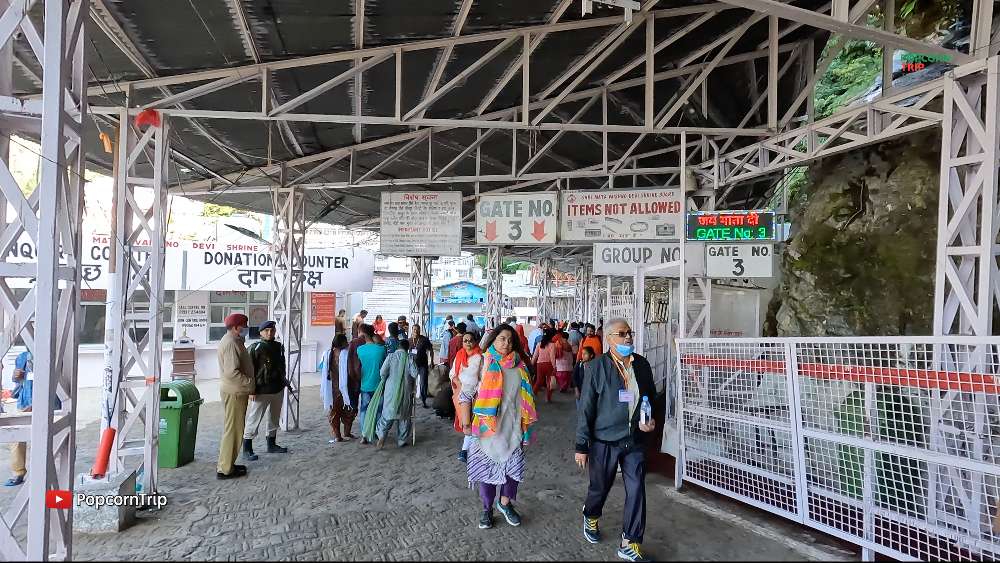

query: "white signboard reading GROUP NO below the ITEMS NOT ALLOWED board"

left=594, top=242, right=705, bottom=277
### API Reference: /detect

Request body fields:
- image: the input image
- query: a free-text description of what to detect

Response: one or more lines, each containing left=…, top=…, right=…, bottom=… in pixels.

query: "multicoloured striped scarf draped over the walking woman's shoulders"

left=472, top=346, right=538, bottom=444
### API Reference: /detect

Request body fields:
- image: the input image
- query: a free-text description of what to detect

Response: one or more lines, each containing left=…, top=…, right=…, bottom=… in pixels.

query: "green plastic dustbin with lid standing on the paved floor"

left=159, top=381, right=205, bottom=467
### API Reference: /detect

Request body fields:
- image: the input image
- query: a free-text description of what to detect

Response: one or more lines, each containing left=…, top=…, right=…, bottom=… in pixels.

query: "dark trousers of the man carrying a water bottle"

left=583, top=441, right=646, bottom=543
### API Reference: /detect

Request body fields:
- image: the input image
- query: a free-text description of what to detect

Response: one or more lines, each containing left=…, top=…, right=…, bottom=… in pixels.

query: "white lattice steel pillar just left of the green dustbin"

left=101, top=109, right=169, bottom=494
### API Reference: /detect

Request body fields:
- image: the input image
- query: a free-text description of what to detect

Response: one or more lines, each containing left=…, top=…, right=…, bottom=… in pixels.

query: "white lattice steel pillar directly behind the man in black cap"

left=271, top=174, right=306, bottom=431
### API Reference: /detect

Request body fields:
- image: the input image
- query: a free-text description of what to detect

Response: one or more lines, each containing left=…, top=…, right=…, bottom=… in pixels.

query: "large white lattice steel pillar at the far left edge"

left=0, top=0, right=88, bottom=561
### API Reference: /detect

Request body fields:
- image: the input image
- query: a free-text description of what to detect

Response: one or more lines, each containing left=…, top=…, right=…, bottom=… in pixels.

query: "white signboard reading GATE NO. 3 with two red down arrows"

left=476, top=192, right=559, bottom=245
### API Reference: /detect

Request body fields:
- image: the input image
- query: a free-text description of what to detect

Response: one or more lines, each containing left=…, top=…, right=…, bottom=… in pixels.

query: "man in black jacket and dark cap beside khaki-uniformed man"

left=243, top=321, right=288, bottom=461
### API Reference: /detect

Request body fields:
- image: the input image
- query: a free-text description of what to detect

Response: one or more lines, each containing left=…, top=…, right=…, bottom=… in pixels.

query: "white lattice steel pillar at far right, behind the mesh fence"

left=926, top=55, right=1000, bottom=552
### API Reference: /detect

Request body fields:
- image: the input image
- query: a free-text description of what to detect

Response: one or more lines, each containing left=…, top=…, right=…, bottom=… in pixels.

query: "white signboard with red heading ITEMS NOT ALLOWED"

left=560, top=189, right=684, bottom=241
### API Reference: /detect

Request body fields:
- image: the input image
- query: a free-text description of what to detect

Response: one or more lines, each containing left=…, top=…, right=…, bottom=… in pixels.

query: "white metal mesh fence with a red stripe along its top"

left=677, top=337, right=1000, bottom=561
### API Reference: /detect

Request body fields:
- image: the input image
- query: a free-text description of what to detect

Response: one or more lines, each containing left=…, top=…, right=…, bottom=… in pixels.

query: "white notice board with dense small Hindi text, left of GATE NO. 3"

left=379, top=191, right=462, bottom=256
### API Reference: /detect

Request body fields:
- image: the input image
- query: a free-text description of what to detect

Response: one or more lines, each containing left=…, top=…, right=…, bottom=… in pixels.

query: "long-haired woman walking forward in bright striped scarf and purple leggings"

left=458, top=324, right=538, bottom=529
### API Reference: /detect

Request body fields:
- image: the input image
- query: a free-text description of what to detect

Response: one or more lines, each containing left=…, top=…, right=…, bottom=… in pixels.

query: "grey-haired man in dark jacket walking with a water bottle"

left=576, top=319, right=656, bottom=561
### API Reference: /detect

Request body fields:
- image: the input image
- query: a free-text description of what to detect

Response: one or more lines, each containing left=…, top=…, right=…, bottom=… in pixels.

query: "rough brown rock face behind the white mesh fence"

left=765, top=131, right=940, bottom=336
